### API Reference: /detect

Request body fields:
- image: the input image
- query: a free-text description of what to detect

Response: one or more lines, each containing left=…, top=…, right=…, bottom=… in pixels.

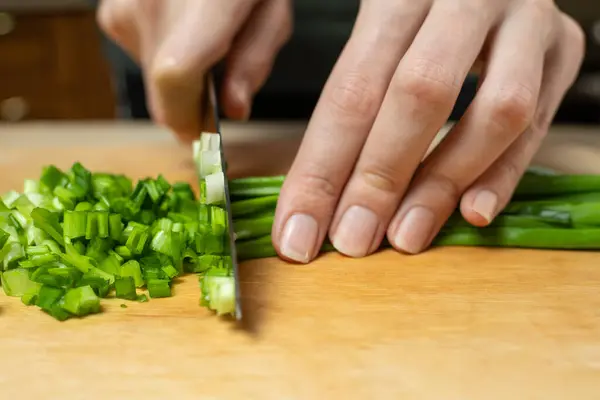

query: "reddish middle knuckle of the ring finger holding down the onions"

left=490, top=85, right=536, bottom=133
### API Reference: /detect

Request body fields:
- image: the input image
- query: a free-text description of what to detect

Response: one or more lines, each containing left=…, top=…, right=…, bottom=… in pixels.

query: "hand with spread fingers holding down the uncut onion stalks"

left=272, top=0, right=584, bottom=262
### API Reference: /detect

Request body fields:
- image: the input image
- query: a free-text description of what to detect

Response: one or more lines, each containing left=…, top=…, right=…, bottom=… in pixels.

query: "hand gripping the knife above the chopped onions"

left=98, top=0, right=292, bottom=141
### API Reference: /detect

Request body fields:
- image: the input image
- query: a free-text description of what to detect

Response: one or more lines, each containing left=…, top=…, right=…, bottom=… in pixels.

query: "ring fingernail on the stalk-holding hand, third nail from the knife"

left=394, top=206, right=435, bottom=254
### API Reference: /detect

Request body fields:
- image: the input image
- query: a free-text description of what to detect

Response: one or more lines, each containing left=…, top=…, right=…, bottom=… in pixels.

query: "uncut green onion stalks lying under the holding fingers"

left=229, top=169, right=600, bottom=260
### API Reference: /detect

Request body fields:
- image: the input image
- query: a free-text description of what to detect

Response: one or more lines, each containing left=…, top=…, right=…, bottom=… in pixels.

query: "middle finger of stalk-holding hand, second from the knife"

left=331, top=2, right=495, bottom=257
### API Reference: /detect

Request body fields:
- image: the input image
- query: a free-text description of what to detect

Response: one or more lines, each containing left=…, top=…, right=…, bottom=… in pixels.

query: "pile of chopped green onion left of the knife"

left=0, top=133, right=235, bottom=321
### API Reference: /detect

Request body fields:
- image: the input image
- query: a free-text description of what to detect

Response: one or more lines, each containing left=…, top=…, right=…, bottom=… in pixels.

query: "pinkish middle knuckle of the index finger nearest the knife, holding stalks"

left=330, top=73, right=379, bottom=117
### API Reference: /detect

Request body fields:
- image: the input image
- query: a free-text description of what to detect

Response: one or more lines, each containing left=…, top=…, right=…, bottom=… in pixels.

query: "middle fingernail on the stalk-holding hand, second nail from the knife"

left=331, top=206, right=379, bottom=257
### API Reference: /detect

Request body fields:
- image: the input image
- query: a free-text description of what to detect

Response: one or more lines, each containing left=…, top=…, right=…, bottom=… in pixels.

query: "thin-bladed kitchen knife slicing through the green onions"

left=201, top=73, right=242, bottom=320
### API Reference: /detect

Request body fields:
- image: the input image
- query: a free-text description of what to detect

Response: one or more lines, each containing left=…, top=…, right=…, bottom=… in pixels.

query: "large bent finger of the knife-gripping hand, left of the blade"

left=145, top=0, right=253, bottom=141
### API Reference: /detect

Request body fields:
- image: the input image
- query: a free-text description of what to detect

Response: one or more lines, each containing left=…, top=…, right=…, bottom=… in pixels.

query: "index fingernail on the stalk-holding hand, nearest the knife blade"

left=280, top=214, right=319, bottom=263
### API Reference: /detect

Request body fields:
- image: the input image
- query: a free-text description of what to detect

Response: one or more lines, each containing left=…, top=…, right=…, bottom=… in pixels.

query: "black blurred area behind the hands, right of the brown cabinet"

left=97, top=0, right=600, bottom=124
